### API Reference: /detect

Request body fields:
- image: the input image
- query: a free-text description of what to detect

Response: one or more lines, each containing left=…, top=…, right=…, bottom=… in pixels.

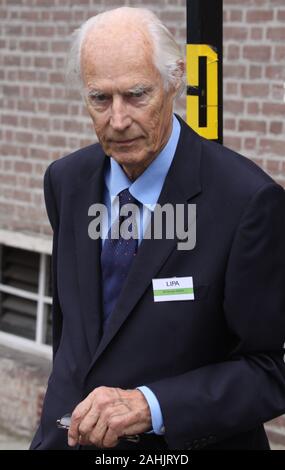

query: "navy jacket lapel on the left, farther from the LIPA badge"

left=73, top=151, right=105, bottom=357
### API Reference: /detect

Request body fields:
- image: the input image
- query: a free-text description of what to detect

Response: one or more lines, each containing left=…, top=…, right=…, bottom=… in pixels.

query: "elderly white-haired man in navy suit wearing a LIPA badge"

left=31, top=8, right=285, bottom=449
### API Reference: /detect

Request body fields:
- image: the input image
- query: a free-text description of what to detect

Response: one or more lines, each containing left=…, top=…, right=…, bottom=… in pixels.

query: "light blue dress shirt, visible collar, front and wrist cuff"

left=102, top=116, right=180, bottom=434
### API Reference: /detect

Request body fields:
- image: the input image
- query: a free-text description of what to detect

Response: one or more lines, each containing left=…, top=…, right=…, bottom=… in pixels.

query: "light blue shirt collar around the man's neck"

left=105, top=115, right=181, bottom=210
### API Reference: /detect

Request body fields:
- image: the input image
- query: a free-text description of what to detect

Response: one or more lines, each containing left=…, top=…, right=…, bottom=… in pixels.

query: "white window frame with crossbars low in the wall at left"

left=0, top=230, right=52, bottom=359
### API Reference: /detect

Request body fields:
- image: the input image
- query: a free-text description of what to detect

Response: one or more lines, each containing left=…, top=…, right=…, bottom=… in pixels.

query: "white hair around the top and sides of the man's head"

left=66, top=7, right=185, bottom=96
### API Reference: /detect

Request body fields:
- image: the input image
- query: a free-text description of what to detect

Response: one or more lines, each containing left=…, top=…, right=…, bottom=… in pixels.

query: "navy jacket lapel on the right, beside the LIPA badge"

left=86, top=119, right=201, bottom=370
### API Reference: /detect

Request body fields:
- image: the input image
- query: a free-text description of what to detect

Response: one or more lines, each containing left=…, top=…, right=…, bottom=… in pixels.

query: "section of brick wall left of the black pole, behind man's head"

left=0, top=0, right=186, bottom=234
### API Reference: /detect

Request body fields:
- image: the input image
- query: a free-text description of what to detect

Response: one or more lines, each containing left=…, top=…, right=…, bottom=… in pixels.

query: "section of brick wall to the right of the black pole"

left=224, top=0, right=285, bottom=185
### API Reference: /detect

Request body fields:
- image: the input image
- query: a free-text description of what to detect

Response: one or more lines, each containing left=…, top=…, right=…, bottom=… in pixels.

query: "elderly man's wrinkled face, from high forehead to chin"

left=81, top=28, right=175, bottom=172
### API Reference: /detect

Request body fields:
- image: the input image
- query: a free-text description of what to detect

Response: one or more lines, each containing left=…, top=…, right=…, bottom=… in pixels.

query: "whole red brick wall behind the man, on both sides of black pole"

left=0, top=0, right=285, bottom=445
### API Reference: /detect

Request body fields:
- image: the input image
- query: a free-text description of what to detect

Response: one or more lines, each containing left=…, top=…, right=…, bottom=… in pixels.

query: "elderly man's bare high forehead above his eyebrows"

left=81, top=28, right=159, bottom=86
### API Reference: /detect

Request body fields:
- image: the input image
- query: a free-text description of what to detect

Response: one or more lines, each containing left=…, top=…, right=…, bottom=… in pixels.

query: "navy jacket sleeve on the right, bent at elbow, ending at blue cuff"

left=148, top=183, right=285, bottom=449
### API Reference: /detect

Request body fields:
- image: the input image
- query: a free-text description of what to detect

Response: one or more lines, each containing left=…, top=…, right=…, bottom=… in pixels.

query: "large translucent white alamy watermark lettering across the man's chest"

left=88, top=197, right=196, bottom=250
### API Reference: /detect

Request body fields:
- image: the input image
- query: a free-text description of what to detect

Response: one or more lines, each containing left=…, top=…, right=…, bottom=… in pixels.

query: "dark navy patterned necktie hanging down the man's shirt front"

left=101, top=189, right=139, bottom=330
